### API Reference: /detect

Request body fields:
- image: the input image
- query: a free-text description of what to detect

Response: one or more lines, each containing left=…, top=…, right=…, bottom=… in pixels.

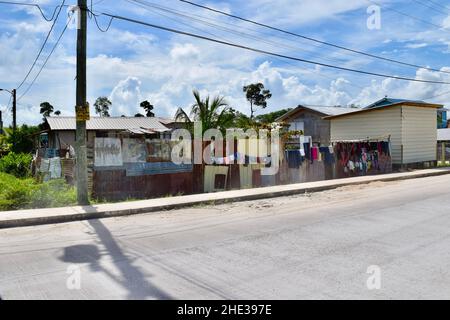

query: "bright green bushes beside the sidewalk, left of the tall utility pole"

left=0, top=172, right=76, bottom=210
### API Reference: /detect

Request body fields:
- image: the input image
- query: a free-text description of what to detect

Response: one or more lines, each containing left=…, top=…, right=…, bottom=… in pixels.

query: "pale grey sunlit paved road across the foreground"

left=0, top=175, right=450, bottom=299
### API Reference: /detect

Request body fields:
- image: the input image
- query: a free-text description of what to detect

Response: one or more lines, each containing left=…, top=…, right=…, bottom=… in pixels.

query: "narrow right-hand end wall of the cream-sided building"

left=402, top=106, right=437, bottom=164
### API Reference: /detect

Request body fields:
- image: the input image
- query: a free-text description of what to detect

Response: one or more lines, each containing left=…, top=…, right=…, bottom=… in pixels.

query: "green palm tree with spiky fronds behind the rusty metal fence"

left=191, top=90, right=229, bottom=133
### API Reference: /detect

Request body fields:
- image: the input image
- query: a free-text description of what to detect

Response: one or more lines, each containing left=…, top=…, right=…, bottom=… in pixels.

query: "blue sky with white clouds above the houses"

left=0, top=0, right=450, bottom=124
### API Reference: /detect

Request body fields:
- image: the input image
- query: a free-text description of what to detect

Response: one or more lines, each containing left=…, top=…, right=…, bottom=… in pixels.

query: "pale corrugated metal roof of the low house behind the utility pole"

left=46, top=117, right=170, bottom=132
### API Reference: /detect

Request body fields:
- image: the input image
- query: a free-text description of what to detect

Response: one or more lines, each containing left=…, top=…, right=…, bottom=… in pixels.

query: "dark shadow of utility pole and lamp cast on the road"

left=61, top=215, right=171, bottom=300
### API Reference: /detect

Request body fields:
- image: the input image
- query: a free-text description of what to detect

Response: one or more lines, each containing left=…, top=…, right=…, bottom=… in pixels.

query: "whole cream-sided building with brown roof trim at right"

left=325, top=98, right=442, bottom=165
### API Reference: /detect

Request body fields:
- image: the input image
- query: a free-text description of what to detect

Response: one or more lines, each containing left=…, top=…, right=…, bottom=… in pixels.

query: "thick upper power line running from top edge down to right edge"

left=179, top=0, right=450, bottom=74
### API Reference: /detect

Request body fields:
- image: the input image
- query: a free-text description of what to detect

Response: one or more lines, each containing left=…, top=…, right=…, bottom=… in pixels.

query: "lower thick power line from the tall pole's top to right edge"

left=96, top=13, right=450, bottom=84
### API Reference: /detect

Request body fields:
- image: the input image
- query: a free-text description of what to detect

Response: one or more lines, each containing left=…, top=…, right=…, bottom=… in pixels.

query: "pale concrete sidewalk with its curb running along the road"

left=0, top=168, right=450, bottom=229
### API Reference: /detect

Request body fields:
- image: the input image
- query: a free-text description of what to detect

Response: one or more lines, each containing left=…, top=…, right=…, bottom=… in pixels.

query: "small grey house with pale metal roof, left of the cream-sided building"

left=276, top=105, right=359, bottom=145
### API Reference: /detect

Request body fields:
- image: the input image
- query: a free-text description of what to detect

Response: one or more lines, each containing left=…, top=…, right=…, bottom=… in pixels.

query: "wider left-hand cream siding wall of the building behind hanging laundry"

left=331, top=106, right=402, bottom=164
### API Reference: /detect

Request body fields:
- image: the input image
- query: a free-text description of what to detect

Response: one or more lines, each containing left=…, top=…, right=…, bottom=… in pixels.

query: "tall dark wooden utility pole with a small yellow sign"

left=75, top=0, right=89, bottom=205
